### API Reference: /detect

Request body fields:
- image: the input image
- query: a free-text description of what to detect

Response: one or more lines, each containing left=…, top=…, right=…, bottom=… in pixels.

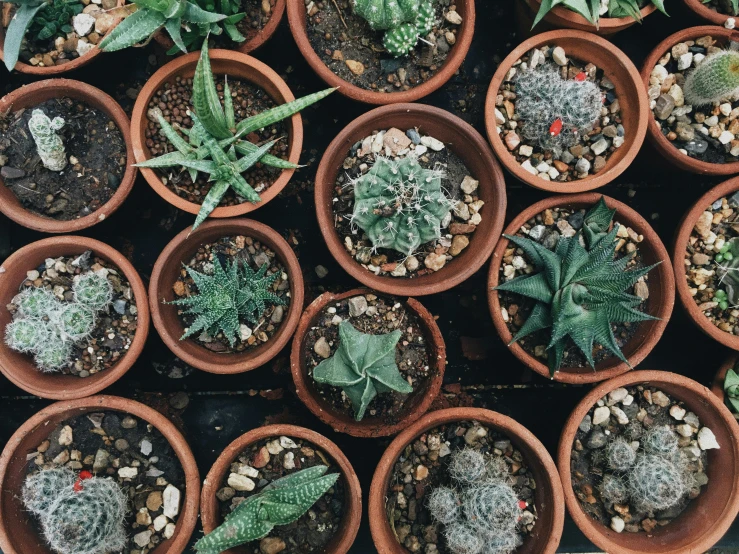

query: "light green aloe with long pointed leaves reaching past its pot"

left=136, top=38, right=336, bottom=230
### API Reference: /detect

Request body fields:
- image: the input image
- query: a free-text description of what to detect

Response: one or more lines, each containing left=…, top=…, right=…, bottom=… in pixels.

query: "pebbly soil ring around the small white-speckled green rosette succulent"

left=174, top=232, right=290, bottom=354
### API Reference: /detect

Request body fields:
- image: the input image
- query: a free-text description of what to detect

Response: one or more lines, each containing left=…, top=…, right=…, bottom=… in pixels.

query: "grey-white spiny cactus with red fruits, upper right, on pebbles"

left=514, top=64, right=603, bottom=157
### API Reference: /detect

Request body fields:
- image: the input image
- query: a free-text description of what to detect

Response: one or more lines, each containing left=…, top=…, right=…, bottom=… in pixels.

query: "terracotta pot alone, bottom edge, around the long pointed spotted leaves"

left=200, top=425, right=362, bottom=554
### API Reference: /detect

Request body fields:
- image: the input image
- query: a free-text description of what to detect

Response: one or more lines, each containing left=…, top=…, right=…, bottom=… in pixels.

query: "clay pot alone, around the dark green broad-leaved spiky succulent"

left=488, top=192, right=675, bottom=384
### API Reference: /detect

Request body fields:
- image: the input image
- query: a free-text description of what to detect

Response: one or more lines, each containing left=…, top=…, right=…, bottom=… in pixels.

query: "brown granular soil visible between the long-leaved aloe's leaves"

left=146, top=76, right=289, bottom=206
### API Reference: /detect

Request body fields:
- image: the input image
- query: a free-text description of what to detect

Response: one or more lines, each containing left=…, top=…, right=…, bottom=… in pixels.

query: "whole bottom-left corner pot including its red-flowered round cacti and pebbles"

left=0, top=396, right=200, bottom=554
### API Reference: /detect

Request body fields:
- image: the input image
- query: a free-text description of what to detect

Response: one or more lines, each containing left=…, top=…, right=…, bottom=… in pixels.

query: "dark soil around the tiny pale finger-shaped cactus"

left=0, top=98, right=126, bottom=221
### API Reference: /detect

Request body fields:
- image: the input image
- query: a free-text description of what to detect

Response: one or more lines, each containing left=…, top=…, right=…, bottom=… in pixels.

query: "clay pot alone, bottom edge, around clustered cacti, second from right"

left=368, top=408, right=565, bottom=554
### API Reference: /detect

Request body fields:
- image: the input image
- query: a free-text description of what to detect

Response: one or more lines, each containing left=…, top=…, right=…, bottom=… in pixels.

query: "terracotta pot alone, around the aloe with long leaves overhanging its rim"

left=131, top=50, right=303, bottom=218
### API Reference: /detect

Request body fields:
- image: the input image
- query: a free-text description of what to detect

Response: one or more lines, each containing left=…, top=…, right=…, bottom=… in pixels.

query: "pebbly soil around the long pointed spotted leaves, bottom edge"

left=217, top=437, right=346, bottom=554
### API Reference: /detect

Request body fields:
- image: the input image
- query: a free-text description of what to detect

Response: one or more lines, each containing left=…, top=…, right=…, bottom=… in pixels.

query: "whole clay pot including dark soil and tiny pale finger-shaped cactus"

left=0, top=79, right=136, bottom=233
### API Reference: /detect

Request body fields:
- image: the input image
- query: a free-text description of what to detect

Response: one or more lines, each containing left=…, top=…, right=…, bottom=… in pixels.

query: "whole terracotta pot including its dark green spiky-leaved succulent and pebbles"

left=488, top=193, right=675, bottom=383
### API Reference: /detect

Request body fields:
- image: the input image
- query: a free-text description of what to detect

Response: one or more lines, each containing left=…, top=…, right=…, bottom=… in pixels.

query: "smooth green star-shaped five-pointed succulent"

left=313, top=321, right=413, bottom=421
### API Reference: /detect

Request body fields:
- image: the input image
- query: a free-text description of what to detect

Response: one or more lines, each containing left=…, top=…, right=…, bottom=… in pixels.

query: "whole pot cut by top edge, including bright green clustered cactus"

left=287, top=0, right=475, bottom=104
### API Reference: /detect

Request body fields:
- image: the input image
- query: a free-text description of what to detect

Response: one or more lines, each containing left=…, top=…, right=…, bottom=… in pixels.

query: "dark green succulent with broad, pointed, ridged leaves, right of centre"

left=495, top=197, right=657, bottom=376
